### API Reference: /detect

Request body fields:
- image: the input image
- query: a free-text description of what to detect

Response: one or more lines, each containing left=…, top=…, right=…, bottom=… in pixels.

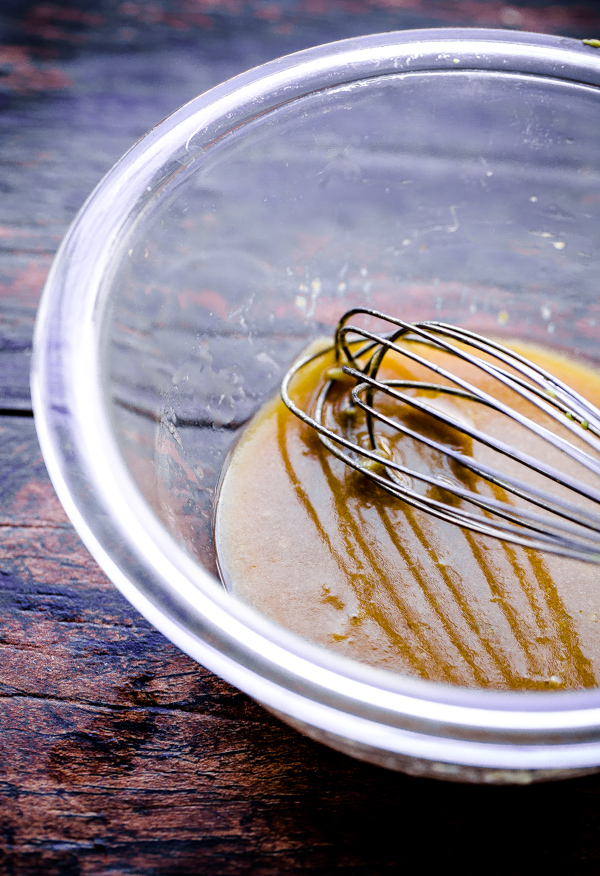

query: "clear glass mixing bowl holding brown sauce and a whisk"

left=32, top=29, right=600, bottom=783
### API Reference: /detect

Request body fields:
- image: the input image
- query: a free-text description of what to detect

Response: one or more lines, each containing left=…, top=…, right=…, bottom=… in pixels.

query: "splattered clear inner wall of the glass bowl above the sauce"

left=102, top=63, right=600, bottom=596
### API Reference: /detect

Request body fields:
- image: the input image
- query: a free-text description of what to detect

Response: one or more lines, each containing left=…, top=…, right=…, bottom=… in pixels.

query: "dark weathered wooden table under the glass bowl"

left=0, top=0, right=600, bottom=876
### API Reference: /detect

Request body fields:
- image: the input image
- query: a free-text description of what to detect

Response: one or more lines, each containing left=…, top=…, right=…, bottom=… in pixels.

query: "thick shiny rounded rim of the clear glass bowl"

left=31, top=28, right=600, bottom=769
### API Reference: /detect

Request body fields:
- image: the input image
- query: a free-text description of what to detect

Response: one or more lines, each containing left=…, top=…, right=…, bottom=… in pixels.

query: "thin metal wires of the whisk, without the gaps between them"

left=281, top=308, right=600, bottom=563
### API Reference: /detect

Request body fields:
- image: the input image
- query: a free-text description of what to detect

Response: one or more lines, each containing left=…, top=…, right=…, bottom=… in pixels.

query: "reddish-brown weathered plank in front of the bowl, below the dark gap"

left=0, top=408, right=600, bottom=876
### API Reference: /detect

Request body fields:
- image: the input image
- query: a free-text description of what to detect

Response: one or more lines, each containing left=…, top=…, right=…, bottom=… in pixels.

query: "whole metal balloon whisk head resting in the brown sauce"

left=281, top=308, right=600, bottom=563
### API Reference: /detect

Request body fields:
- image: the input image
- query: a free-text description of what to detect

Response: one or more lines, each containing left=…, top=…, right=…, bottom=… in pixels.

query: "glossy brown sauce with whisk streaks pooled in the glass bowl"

left=215, top=344, right=600, bottom=690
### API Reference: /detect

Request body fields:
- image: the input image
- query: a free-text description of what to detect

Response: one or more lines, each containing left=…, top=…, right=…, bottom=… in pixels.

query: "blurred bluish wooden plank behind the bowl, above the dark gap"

left=0, top=0, right=600, bottom=409
